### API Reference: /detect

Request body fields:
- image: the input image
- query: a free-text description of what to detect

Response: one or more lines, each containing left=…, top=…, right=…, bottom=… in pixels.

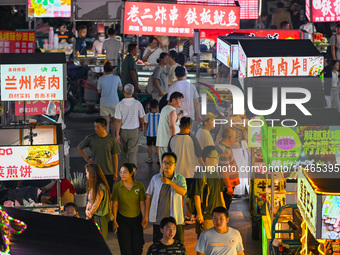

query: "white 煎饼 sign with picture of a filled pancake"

left=0, top=145, right=59, bottom=181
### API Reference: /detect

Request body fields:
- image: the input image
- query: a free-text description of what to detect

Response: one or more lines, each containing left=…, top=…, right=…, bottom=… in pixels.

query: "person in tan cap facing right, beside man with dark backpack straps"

left=196, top=112, right=217, bottom=150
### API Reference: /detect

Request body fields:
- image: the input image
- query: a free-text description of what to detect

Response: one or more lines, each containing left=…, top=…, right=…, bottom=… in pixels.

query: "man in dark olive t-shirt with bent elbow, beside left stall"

left=77, top=118, right=120, bottom=189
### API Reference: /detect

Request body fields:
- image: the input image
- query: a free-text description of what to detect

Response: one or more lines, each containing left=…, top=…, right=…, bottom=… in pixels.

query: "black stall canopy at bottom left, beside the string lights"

left=5, top=208, right=111, bottom=255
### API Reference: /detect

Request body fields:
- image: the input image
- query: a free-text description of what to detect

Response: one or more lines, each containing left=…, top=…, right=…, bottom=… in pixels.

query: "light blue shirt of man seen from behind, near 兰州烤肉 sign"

left=97, top=74, right=122, bottom=105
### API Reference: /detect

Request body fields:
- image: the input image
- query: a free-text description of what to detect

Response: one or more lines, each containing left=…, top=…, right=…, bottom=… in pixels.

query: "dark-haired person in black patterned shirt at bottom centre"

left=147, top=217, right=187, bottom=255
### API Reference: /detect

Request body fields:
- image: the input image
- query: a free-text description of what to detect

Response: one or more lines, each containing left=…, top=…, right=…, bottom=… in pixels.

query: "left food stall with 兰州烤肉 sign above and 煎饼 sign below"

left=0, top=53, right=68, bottom=211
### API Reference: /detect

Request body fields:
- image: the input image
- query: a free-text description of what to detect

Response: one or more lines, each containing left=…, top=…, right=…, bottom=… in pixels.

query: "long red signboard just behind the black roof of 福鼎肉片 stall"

left=200, top=29, right=302, bottom=42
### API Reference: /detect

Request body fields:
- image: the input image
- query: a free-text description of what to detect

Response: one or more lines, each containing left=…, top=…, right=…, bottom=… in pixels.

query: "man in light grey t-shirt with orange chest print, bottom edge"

left=195, top=207, right=244, bottom=255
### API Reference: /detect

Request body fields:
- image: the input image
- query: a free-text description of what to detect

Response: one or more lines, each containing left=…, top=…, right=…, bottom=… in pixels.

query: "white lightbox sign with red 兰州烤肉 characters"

left=1, top=64, right=64, bottom=101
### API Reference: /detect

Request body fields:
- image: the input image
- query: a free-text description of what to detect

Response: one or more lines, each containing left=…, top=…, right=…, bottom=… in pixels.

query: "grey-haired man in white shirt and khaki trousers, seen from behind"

left=115, top=83, right=145, bottom=166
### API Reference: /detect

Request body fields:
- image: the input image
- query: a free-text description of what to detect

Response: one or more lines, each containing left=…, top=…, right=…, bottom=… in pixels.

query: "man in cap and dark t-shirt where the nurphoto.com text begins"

left=194, top=146, right=225, bottom=238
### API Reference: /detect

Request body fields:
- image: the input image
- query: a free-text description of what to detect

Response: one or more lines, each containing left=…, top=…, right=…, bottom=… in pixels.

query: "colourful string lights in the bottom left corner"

left=0, top=206, right=27, bottom=255
